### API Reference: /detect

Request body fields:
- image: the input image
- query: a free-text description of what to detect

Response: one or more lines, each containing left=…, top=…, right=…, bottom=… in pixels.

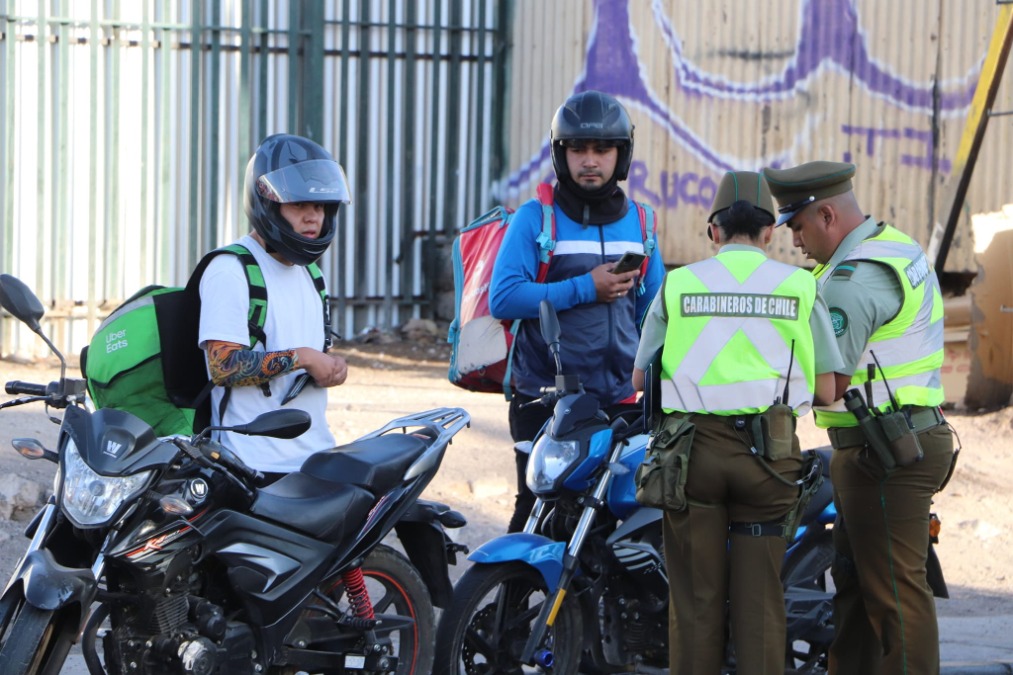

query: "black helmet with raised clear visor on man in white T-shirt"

left=243, top=134, right=350, bottom=266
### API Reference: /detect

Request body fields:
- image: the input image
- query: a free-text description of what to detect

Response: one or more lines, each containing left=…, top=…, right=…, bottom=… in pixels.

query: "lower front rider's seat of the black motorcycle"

left=250, top=471, right=376, bottom=542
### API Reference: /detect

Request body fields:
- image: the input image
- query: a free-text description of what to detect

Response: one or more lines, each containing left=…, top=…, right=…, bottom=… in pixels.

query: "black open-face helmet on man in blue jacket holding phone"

left=549, top=90, right=633, bottom=188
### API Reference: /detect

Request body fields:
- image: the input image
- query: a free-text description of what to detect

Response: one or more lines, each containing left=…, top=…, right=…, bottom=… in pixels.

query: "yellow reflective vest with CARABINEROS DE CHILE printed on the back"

left=661, top=250, right=816, bottom=416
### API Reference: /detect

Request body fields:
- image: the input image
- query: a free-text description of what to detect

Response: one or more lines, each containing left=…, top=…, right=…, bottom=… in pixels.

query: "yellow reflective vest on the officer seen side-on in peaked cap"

left=812, top=225, right=943, bottom=429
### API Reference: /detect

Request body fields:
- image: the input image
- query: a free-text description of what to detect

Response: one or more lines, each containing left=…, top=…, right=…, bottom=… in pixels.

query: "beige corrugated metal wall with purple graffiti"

left=497, top=0, right=1013, bottom=272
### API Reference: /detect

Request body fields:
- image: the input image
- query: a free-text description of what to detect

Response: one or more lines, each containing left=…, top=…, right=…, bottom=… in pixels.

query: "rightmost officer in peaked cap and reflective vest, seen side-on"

left=763, top=161, right=953, bottom=675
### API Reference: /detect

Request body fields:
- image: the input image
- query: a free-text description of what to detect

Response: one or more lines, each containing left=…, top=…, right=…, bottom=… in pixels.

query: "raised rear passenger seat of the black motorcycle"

left=299, top=434, right=428, bottom=496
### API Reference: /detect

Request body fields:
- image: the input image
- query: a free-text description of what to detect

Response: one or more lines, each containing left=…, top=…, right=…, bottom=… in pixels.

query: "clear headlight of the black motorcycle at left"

left=60, top=437, right=152, bottom=527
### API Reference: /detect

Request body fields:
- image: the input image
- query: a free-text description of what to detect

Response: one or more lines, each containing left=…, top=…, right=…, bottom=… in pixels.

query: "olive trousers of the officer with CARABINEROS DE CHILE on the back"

left=664, top=416, right=801, bottom=675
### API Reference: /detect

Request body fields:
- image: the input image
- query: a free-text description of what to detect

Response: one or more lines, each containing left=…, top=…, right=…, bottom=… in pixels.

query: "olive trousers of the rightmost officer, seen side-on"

left=830, top=425, right=953, bottom=675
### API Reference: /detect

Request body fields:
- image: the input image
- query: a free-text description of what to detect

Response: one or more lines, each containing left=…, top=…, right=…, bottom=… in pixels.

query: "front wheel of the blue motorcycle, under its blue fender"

left=434, top=563, right=583, bottom=675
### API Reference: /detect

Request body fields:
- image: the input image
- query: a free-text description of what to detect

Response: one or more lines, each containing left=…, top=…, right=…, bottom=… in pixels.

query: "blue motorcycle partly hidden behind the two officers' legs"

left=435, top=301, right=941, bottom=675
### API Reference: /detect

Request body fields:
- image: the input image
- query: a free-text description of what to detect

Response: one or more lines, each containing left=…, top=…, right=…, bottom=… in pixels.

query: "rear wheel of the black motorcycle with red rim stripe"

left=324, top=545, right=436, bottom=675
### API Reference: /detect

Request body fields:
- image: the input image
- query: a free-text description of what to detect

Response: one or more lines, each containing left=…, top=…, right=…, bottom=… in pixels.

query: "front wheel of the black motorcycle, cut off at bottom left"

left=0, top=592, right=76, bottom=675
